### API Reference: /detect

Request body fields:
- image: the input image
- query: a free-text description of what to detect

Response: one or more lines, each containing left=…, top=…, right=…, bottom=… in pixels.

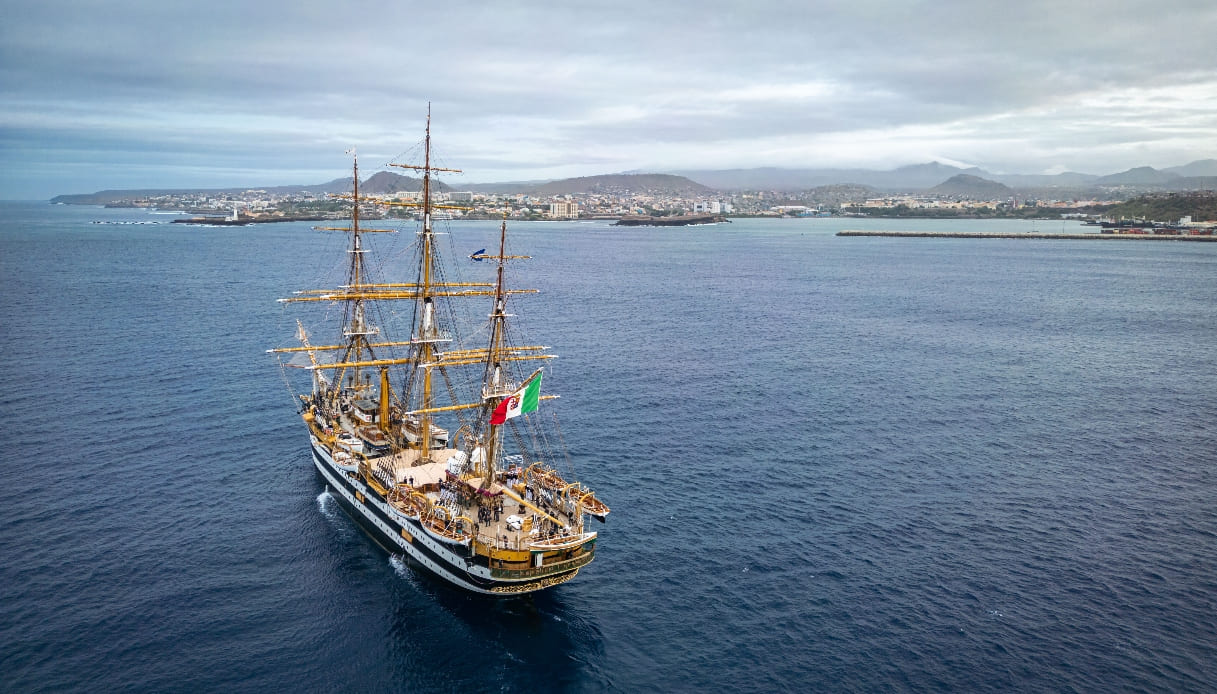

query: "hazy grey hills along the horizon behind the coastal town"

left=51, top=159, right=1217, bottom=199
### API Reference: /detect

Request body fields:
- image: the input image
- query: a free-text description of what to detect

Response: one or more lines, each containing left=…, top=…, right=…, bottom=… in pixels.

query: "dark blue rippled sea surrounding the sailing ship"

left=0, top=203, right=1217, bottom=693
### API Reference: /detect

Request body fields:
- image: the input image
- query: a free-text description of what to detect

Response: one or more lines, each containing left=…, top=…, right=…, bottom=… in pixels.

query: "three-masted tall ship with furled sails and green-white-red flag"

left=269, top=111, right=609, bottom=595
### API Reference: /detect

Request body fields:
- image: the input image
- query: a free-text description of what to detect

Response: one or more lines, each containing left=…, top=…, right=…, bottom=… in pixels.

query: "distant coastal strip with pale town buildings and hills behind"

left=51, top=163, right=1217, bottom=224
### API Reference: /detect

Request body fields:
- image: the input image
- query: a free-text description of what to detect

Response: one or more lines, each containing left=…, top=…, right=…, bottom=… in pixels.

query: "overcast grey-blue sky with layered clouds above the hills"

left=0, top=0, right=1217, bottom=200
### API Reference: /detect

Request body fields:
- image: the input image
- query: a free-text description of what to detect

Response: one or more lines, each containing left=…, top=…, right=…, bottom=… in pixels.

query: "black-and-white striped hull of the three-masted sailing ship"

left=309, top=440, right=593, bottom=597
